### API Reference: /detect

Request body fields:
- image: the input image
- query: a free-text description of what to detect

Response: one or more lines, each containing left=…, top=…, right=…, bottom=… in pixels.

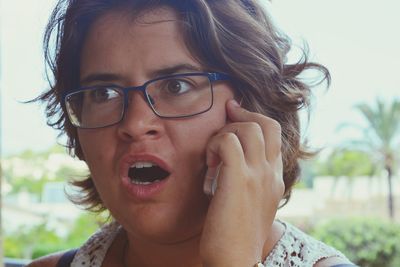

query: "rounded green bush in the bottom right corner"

left=311, top=218, right=400, bottom=267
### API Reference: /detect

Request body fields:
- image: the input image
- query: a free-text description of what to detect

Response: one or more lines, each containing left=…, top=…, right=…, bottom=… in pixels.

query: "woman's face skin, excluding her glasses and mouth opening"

left=78, top=9, right=234, bottom=242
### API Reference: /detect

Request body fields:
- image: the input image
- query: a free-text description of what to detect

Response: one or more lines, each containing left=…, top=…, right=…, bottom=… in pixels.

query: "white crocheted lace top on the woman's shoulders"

left=71, top=221, right=347, bottom=267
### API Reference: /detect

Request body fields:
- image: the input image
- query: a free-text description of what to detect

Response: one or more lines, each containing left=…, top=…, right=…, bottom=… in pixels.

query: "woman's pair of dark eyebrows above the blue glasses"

left=80, top=64, right=203, bottom=84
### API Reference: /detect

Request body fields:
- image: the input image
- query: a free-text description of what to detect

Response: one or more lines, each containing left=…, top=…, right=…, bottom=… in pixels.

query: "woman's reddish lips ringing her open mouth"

left=120, top=154, right=171, bottom=201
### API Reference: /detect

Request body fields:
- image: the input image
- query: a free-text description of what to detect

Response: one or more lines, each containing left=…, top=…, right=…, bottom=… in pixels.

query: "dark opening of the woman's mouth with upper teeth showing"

left=128, top=162, right=170, bottom=185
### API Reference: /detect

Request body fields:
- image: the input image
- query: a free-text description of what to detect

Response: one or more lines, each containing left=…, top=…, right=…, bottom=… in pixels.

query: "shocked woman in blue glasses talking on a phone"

left=30, top=0, right=356, bottom=267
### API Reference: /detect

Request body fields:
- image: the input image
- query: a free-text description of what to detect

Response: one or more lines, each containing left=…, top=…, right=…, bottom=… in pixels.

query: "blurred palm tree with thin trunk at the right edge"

left=354, top=99, right=400, bottom=219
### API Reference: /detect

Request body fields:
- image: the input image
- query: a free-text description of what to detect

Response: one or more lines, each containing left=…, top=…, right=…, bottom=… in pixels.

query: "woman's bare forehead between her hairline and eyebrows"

left=80, top=7, right=200, bottom=82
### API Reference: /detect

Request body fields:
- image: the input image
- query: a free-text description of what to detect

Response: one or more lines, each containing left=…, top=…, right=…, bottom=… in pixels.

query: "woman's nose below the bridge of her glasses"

left=118, top=92, right=163, bottom=142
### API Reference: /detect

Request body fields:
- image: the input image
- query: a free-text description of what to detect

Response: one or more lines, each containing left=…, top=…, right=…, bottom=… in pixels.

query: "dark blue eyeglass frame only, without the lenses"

left=61, top=72, right=232, bottom=129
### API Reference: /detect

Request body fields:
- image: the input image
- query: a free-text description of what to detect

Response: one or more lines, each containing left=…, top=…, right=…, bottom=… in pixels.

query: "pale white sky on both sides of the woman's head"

left=0, top=0, right=400, bottom=156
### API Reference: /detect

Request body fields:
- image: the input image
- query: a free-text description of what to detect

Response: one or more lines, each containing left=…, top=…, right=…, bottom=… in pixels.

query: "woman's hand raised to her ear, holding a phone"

left=200, top=100, right=285, bottom=267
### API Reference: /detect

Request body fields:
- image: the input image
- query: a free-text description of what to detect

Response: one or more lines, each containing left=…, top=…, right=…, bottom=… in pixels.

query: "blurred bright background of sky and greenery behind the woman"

left=0, top=0, right=400, bottom=267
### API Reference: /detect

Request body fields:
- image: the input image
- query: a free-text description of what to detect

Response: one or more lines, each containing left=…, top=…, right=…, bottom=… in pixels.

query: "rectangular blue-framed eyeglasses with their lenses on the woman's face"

left=62, top=72, right=230, bottom=129
